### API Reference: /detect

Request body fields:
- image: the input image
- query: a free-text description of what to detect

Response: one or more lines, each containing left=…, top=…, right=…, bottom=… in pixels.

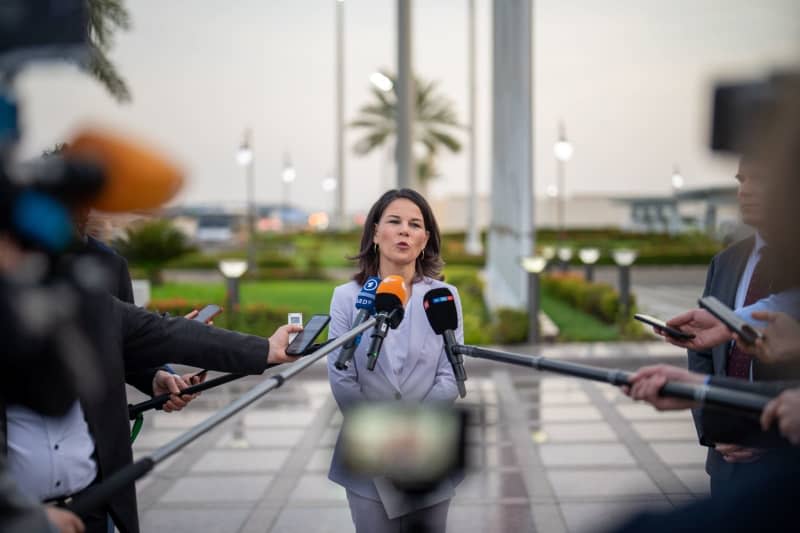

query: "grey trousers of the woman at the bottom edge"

left=347, top=490, right=450, bottom=533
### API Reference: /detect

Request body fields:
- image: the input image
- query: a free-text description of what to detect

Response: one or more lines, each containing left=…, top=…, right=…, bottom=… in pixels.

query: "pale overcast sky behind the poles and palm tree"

left=14, top=0, right=800, bottom=214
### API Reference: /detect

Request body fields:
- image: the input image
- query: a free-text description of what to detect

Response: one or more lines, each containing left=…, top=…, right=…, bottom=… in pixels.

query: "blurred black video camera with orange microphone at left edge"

left=0, top=0, right=182, bottom=416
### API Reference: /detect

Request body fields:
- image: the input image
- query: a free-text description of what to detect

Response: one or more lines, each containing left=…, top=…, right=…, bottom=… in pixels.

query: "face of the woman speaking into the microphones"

left=372, top=198, right=429, bottom=265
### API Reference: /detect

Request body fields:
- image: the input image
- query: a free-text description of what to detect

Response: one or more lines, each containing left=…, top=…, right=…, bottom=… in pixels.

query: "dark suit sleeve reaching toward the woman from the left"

left=114, top=299, right=269, bottom=374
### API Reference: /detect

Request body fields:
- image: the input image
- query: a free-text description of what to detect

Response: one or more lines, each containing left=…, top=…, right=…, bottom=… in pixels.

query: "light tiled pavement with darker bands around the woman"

left=128, top=346, right=708, bottom=533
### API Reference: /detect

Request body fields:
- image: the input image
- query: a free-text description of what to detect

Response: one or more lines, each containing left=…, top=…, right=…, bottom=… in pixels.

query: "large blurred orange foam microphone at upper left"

left=64, top=129, right=183, bottom=212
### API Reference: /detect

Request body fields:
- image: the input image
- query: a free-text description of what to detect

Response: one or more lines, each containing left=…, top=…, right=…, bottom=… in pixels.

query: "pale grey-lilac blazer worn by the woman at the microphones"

left=328, top=278, right=464, bottom=518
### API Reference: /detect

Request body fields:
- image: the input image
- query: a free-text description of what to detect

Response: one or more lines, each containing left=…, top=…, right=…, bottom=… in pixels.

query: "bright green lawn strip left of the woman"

left=151, top=280, right=338, bottom=316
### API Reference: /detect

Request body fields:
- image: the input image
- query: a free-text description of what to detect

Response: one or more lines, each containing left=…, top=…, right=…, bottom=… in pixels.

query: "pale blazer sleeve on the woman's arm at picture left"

left=328, top=286, right=365, bottom=412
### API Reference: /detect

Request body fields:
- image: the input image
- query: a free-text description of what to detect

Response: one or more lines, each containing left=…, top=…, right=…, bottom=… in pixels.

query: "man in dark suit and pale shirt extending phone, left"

left=1, top=237, right=302, bottom=533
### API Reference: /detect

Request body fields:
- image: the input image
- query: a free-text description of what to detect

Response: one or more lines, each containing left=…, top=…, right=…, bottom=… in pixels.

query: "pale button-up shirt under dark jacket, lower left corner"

left=6, top=401, right=97, bottom=501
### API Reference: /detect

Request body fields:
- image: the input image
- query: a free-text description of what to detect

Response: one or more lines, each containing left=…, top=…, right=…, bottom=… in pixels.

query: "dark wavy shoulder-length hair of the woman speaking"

left=349, top=189, right=444, bottom=285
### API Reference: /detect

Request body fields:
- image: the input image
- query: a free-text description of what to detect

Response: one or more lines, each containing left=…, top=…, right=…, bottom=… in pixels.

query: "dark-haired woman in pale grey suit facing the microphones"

left=328, top=189, right=464, bottom=533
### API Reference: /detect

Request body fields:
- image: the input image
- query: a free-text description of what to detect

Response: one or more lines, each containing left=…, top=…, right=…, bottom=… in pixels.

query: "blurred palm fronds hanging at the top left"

left=86, top=0, right=131, bottom=102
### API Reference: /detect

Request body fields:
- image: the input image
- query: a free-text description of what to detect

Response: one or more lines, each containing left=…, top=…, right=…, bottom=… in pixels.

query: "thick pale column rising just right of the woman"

left=487, top=0, right=534, bottom=309
